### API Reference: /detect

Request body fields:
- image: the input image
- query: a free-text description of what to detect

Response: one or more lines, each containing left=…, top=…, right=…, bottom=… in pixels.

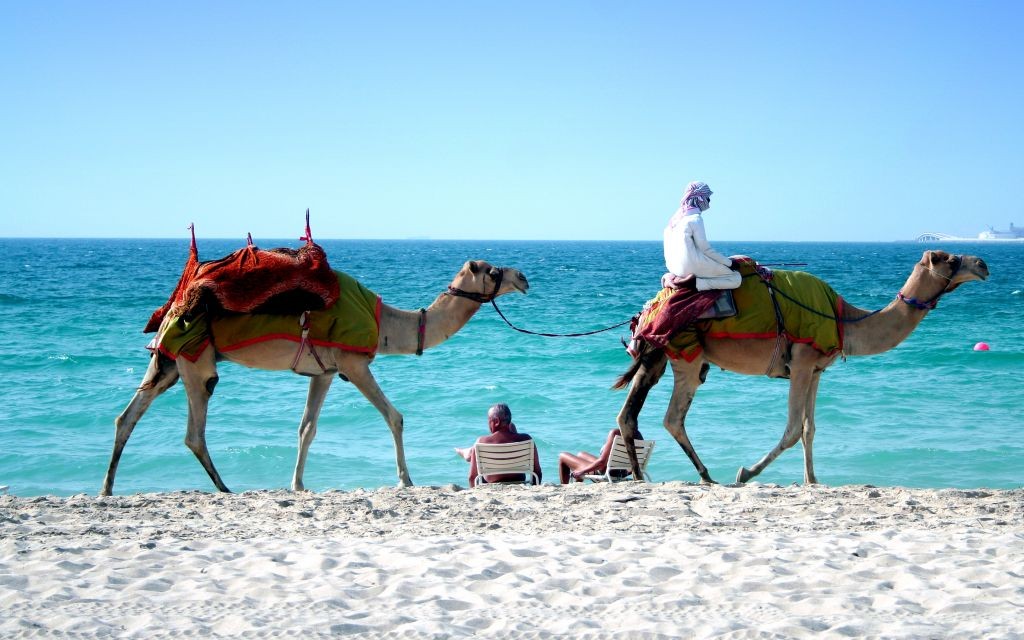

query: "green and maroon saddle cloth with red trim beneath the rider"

left=640, top=260, right=843, bottom=362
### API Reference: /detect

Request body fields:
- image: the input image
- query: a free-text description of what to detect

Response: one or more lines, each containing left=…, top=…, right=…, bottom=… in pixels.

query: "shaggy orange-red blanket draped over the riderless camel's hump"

left=143, top=237, right=339, bottom=333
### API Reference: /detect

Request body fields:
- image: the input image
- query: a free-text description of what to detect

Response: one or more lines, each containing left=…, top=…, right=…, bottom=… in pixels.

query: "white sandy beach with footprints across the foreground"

left=0, top=482, right=1024, bottom=638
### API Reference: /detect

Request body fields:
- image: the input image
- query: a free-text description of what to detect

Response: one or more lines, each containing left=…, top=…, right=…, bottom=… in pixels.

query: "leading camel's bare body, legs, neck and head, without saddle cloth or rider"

left=612, top=251, right=988, bottom=484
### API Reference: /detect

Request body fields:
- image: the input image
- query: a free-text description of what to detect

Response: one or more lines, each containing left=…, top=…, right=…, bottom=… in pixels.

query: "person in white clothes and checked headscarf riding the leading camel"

left=665, top=178, right=742, bottom=291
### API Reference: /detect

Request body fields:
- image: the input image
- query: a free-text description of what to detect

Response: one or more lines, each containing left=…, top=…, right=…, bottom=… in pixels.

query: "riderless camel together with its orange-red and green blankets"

left=100, top=229, right=529, bottom=496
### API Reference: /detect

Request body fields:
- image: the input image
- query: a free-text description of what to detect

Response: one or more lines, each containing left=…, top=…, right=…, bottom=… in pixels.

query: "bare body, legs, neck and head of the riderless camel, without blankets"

left=99, top=260, right=529, bottom=496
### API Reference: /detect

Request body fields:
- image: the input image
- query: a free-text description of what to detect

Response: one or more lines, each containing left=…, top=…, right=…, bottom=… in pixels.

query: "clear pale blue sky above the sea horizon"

left=0, top=0, right=1024, bottom=243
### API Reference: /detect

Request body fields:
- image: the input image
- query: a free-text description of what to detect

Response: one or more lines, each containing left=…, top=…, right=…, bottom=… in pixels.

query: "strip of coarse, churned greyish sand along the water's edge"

left=0, top=481, right=1024, bottom=541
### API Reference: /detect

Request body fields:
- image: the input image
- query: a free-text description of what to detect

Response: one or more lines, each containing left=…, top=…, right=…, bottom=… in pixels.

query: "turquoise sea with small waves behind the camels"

left=0, top=238, right=1024, bottom=496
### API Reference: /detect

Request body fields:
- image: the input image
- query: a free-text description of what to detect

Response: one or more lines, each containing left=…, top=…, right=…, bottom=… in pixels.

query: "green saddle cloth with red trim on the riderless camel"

left=157, top=271, right=381, bottom=361
